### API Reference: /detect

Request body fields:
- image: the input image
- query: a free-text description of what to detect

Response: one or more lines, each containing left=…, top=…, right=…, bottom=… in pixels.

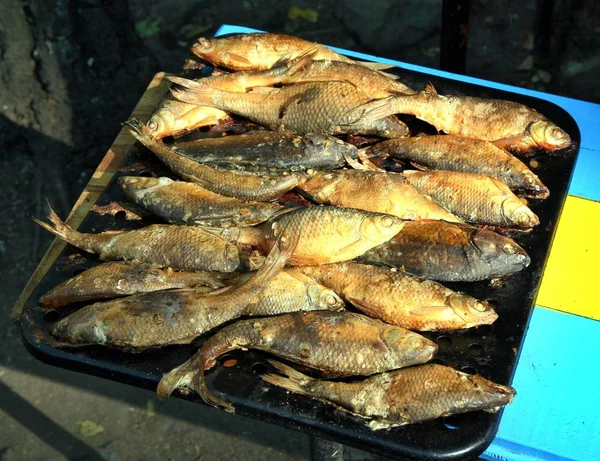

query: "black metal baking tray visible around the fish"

left=21, top=51, right=580, bottom=460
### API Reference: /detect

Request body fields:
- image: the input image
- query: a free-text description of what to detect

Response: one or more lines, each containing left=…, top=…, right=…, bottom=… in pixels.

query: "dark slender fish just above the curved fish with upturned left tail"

left=172, top=131, right=357, bottom=171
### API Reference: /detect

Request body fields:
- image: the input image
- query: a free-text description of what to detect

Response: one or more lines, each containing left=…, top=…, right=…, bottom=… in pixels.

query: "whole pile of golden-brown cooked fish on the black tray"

left=36, top=34, right=571, bottom=429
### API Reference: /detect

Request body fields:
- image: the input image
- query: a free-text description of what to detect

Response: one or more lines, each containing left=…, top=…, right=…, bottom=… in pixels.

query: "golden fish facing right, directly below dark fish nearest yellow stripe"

left=299, top=262, right=498, bottom=331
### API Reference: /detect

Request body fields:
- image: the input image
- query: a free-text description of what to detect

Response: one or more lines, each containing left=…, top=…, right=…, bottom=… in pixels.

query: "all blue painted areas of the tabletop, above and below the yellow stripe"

left=216, top=25, right=600, bottom=461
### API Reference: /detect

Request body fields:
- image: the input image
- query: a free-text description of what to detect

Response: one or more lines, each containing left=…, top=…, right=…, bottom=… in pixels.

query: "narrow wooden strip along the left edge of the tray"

left=11, top=72, right=169, bottom=322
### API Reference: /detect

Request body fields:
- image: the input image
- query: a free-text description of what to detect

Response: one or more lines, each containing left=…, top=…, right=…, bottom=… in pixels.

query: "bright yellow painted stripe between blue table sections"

left=536, top=195, right=600, bottom=320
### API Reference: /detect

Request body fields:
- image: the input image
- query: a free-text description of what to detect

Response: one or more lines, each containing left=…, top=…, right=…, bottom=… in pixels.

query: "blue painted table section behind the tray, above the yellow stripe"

left=216, top=25, right=600, bottom=201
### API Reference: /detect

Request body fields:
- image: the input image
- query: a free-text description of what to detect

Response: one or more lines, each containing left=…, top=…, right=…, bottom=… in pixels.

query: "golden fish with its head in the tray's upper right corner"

left=362, top=85, right=572, bottom=153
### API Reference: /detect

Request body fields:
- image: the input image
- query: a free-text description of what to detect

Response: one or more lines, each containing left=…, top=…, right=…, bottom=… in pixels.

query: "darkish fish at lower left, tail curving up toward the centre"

left=52, top=232, right=294, bottom=351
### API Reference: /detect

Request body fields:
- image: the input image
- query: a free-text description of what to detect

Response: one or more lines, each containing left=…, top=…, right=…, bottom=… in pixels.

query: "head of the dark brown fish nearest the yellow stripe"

left=470, top=229, right=531, bottom=274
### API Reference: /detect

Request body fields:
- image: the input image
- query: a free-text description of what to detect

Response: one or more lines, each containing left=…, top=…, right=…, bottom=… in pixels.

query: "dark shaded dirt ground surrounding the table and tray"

left=0, top=0, right=600, bottom=461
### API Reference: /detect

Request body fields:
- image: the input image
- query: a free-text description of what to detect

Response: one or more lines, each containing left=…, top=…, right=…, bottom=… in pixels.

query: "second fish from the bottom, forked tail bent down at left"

left=157, top=311, right=437, bottom=412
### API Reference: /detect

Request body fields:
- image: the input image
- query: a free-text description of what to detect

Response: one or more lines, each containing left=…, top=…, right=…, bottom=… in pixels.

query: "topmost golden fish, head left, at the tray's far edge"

left=191, top=33, right=392, bottom=70
